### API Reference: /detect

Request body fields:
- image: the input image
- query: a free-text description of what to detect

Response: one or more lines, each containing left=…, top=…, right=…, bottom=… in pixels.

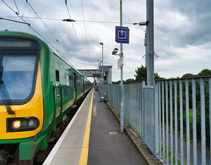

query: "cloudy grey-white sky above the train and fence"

left=0, top=0, right=211, bottom=81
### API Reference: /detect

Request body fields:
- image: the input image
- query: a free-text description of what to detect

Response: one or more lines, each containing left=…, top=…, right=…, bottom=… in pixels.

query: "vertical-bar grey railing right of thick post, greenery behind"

left=156, top=78, right=211, bottom=165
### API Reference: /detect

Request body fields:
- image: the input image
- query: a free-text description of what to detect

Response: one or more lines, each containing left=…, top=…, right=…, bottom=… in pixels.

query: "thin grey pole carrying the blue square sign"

left=120, top=0, right=124, bottom=132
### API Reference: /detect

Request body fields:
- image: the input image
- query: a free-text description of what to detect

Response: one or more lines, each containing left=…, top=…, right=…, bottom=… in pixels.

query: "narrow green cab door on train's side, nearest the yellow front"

left=51, top=61, right=62, bottom=127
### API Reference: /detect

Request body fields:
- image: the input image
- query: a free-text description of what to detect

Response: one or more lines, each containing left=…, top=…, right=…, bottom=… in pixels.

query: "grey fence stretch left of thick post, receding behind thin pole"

left=99, top=83, right=142, bottom=137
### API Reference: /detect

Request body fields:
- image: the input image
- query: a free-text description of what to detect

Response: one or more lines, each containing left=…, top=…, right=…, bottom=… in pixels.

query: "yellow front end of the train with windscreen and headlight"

left=0, top=32, right=43, bottom=164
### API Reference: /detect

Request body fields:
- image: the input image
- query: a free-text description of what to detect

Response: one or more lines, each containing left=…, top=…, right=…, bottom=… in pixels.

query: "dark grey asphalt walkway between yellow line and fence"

left=88, top=91, right=147, bottom=165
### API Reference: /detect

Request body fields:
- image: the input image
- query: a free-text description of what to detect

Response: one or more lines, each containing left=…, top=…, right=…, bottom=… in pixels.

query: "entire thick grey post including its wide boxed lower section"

left=143, top=0, right=158, bottom=155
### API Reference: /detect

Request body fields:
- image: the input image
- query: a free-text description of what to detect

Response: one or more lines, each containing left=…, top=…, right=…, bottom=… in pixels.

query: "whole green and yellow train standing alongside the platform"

left=0, top=30, right=92, bottom=165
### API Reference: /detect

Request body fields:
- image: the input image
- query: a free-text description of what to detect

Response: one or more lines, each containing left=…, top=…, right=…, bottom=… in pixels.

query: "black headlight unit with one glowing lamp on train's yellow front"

left=7, top=117, right=40, bottom=132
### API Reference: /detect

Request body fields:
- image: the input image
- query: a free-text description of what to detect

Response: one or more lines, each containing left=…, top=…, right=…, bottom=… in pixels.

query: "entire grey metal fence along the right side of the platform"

left=99, top=77, right=211, bottom=165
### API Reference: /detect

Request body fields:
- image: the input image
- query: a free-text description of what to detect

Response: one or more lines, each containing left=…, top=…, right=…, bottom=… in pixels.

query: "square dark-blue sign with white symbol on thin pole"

left=115, top=26, right=129, bottom=43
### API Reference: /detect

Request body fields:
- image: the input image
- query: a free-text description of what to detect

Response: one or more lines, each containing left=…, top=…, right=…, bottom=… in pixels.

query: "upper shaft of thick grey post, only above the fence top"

left=146, top=0, right=154, bottom=86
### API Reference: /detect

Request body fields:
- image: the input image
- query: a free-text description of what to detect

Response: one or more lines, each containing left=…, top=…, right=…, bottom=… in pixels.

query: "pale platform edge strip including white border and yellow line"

left=43, top=90, right=93, bottom=165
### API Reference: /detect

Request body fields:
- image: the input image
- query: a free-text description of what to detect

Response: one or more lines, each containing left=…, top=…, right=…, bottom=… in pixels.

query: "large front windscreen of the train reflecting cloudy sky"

left=0, top=54, right=37, bottom=102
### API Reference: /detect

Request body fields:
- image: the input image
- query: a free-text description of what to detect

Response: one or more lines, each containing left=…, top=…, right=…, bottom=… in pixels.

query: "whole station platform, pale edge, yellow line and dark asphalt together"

left=43, top=89, right=148, bottom=165
